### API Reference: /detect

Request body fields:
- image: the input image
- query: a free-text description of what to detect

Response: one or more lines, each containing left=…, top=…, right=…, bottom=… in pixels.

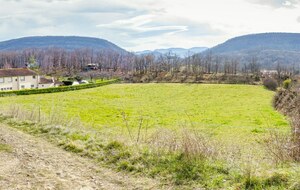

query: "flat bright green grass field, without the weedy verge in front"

left=0, top=84, right=288, bottom=142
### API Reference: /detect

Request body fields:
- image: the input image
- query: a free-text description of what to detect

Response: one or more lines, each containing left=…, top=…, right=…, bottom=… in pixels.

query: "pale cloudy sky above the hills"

left=0, top=0, right=300, bottom=51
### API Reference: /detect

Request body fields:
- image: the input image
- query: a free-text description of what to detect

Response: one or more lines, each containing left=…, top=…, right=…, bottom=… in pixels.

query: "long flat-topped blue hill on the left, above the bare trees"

left=0, top=36, right=126, bottom=52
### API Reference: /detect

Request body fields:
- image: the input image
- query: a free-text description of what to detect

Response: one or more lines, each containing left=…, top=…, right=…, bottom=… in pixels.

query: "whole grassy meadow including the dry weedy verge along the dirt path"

left=0, top=84, right=300, bottom=189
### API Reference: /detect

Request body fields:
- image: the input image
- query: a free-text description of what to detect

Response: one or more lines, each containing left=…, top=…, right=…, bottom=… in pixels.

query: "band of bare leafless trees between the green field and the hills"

left=0, top=48, right=297, bottom=79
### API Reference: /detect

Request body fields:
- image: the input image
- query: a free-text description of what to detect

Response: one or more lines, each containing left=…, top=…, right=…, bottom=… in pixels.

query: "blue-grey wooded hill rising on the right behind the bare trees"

left=207, top=33, right=300, bottom=68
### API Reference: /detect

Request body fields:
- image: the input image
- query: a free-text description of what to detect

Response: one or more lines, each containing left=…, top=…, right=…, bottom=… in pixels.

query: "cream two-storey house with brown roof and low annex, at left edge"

left=0, top=68, right=55, bottom=91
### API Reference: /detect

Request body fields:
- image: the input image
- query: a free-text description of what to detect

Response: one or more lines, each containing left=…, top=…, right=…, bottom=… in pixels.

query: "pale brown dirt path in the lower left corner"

left=0, top=124, right=162, bottom=190
